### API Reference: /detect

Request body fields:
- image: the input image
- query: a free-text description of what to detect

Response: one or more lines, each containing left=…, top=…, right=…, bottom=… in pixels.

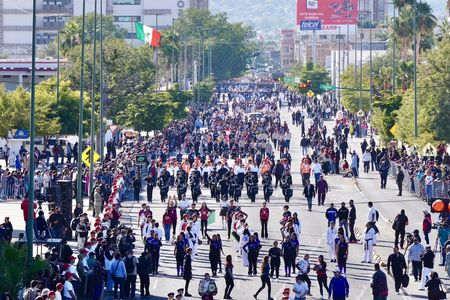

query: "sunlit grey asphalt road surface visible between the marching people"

left=0, top=104, right=446, bottom=299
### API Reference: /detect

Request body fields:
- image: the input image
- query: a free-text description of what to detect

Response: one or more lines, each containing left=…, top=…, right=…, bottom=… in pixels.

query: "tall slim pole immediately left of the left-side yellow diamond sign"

left=75, top=0, right=86, bottom=207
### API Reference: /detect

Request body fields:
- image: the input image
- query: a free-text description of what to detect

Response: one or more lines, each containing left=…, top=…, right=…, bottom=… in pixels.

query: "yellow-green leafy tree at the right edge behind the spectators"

left=397, top=37, right=450, bottom=145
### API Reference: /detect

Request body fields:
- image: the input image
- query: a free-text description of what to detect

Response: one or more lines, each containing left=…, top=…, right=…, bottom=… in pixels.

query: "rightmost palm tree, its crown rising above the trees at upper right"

left=414, top=2, right=437, bottom=64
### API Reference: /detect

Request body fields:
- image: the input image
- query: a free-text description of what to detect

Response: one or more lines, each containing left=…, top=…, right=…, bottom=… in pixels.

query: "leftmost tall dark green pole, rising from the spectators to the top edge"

left=26, top=0, right=36, bottom=269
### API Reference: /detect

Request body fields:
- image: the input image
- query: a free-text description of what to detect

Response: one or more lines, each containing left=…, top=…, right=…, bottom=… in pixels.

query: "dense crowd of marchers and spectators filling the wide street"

left=0, top=77, right=450, bottom=300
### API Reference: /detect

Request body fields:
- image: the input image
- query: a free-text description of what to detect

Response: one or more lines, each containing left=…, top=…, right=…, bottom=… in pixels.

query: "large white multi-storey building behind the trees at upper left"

left=0, top=0, right=208, bottom=55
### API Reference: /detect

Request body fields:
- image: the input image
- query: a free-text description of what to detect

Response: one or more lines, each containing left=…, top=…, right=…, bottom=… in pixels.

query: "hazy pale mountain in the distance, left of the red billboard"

left=209, top=0, right=447, bottom=40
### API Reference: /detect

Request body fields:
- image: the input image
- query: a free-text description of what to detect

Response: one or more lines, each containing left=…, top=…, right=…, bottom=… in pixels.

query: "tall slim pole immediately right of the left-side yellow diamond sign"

left=89, top=0, right=97, bottom=204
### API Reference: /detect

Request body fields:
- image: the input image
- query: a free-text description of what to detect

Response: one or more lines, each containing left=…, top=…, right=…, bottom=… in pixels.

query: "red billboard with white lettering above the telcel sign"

left=297, top=0, right=358, bottom=30
